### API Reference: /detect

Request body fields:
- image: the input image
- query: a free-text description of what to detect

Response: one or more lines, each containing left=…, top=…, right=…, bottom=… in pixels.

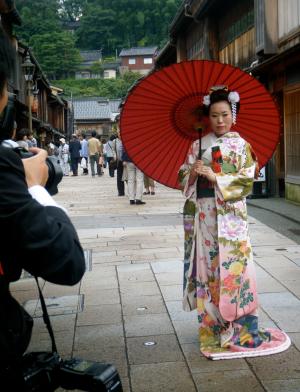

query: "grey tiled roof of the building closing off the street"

left=73, top=97, right=121, bottom=120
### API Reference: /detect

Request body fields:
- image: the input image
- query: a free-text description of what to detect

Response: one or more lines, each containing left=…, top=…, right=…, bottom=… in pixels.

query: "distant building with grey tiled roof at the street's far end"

left=73, top=97, right=121, bottom=137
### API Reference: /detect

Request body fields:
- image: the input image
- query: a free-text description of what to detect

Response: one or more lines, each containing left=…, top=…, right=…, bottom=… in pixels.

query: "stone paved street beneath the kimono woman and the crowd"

left=12, top=171, right=300, bottom=392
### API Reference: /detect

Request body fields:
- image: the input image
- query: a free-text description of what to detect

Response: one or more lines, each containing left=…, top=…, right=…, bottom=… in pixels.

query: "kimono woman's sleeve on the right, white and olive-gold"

left=216, top=143, right=257, bottom=201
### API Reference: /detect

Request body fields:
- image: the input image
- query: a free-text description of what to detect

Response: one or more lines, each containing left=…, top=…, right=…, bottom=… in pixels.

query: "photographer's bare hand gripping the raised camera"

left=22, top=147, right=49, bottom=188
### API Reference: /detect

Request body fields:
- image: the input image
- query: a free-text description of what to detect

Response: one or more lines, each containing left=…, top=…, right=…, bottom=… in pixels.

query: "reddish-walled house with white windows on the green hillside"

left=119, top=46, right=157, bottom=75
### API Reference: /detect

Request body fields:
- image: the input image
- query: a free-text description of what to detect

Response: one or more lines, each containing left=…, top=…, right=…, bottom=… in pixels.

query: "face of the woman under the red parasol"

left=209, top=101, right=232, bottom=136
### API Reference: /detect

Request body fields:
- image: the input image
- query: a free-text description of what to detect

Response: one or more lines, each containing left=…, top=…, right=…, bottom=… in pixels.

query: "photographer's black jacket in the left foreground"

left=0, top=146, right=85, bottom=361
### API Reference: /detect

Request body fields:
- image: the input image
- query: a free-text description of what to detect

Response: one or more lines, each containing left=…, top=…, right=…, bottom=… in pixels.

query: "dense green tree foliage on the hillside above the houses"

left=16, top=0, right=181, bottom=78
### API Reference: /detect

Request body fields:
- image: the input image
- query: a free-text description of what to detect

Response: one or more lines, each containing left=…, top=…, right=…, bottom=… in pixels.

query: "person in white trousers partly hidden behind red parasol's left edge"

left=122, top=146, right=146, bottom=205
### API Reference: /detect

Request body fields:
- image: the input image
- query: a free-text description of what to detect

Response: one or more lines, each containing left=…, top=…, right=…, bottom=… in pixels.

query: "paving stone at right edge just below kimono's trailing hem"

left=247, top=346, right=300, bottom=380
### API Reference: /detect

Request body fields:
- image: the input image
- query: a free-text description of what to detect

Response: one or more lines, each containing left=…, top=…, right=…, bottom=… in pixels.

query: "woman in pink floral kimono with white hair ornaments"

left=179, top=86, right=290, bottom=359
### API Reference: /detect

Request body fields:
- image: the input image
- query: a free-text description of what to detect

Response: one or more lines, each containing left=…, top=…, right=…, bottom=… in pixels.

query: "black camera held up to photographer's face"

left=14, top=147, right=63, bottom=195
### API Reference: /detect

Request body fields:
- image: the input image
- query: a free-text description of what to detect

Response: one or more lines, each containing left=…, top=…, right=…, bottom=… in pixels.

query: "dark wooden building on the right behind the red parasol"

left=155, top=0, right=300, bottom=203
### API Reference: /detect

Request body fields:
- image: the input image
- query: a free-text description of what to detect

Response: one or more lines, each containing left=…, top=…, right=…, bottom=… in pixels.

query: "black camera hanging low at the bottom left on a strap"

left=22, top=352, right=123, bottom=392
